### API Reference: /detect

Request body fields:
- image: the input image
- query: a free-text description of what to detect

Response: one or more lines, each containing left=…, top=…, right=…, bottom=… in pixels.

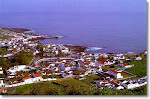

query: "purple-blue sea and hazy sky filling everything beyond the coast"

left=0, top=0, right=147, bottom=53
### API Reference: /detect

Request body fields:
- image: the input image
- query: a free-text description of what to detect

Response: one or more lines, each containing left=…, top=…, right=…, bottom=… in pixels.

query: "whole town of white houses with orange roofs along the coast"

left=0, top=28, right=147, bottom=93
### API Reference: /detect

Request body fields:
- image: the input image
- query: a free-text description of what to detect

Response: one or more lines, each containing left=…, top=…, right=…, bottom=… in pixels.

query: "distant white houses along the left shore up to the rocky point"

left=0, top=27, right=69, bottom=58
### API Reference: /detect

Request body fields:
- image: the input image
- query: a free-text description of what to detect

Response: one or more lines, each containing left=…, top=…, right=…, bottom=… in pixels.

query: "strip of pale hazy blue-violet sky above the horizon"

left=0, top=0, right=147, bottom=12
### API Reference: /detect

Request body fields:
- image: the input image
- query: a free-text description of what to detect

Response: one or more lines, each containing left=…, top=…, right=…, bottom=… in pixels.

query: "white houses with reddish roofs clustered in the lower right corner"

left=96, top=76, right=147, bottom=90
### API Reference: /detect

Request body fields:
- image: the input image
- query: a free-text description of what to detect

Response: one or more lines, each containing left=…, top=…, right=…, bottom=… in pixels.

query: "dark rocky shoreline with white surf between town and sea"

left=0, top=27, right=145, bottom=54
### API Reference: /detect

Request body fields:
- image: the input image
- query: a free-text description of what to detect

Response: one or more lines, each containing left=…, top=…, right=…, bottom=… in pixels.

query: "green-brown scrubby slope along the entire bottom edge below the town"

left=11, top=76, right=147, bottom=95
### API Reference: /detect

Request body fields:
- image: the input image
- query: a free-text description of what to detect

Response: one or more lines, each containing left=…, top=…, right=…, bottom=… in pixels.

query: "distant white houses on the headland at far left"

left=0, top=31, right=37, bottom=58
